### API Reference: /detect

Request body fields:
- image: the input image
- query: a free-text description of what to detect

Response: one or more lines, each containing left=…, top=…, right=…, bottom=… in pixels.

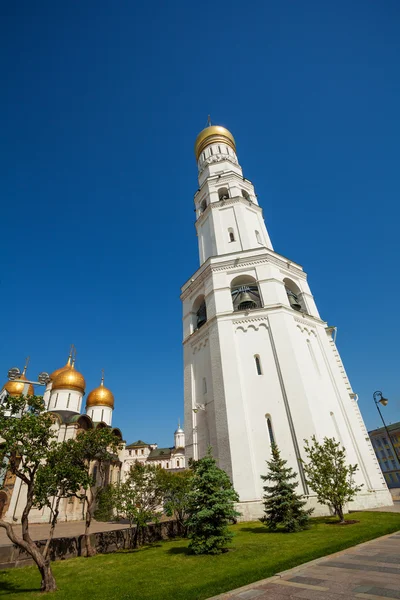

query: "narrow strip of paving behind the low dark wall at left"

left=0, top=520, right=129, bottom=546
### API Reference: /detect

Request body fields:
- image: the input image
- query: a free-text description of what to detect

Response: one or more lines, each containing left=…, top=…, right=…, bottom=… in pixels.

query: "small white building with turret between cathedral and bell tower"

left=122, top=424, right=186, bottom=477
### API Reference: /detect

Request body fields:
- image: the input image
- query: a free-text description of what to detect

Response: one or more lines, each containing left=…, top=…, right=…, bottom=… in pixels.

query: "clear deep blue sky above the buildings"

left=0, top=0, right=400, bottom=445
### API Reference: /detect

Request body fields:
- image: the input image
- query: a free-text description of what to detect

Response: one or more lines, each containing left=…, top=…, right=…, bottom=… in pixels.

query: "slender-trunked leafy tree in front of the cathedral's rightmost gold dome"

left=75, top=427, right=122, bottom=556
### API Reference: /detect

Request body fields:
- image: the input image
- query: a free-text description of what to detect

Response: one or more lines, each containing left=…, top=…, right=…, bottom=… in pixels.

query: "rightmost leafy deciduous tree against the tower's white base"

left=304, top=435, right=362, bottom=523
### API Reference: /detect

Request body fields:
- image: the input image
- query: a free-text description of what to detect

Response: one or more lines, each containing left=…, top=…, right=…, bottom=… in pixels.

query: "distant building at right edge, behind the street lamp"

left=368, top=422, right=400, bottom=488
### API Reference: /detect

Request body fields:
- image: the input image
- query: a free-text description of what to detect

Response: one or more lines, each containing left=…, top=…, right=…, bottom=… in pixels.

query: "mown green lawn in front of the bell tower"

left=0, top=512, right=400, bottom=600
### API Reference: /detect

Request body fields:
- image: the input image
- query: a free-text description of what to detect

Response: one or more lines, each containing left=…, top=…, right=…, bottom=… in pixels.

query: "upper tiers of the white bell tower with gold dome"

left=194, top=125, right=273, bottom=264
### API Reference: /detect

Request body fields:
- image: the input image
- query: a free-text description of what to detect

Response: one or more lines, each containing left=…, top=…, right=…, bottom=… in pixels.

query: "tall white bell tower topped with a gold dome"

left=181, top=126, right=392, bottom=520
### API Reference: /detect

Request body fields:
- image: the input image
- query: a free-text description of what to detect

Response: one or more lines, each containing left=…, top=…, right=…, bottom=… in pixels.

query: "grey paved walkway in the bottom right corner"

left=209, top=532, right=400, bottom=600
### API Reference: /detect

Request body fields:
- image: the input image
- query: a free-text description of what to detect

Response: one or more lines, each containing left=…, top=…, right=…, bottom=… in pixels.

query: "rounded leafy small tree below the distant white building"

left=114, top=461, right=165, bottom=548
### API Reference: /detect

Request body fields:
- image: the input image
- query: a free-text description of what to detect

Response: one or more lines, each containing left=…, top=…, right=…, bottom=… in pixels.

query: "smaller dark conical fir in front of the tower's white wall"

left=261, top=444, right=313, bottom=532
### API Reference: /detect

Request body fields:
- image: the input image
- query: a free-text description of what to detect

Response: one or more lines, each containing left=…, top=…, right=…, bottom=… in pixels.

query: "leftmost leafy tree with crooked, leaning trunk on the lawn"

left=0, top=396, right=57, bottom=592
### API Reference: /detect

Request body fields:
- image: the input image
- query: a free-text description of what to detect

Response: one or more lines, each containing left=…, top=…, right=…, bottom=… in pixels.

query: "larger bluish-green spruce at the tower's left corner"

left=187, top=449, right=240, bottom=554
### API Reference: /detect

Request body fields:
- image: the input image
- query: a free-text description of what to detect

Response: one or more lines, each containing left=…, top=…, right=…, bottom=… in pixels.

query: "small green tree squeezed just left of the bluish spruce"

left=159, top=470, right=193, bottom=536
